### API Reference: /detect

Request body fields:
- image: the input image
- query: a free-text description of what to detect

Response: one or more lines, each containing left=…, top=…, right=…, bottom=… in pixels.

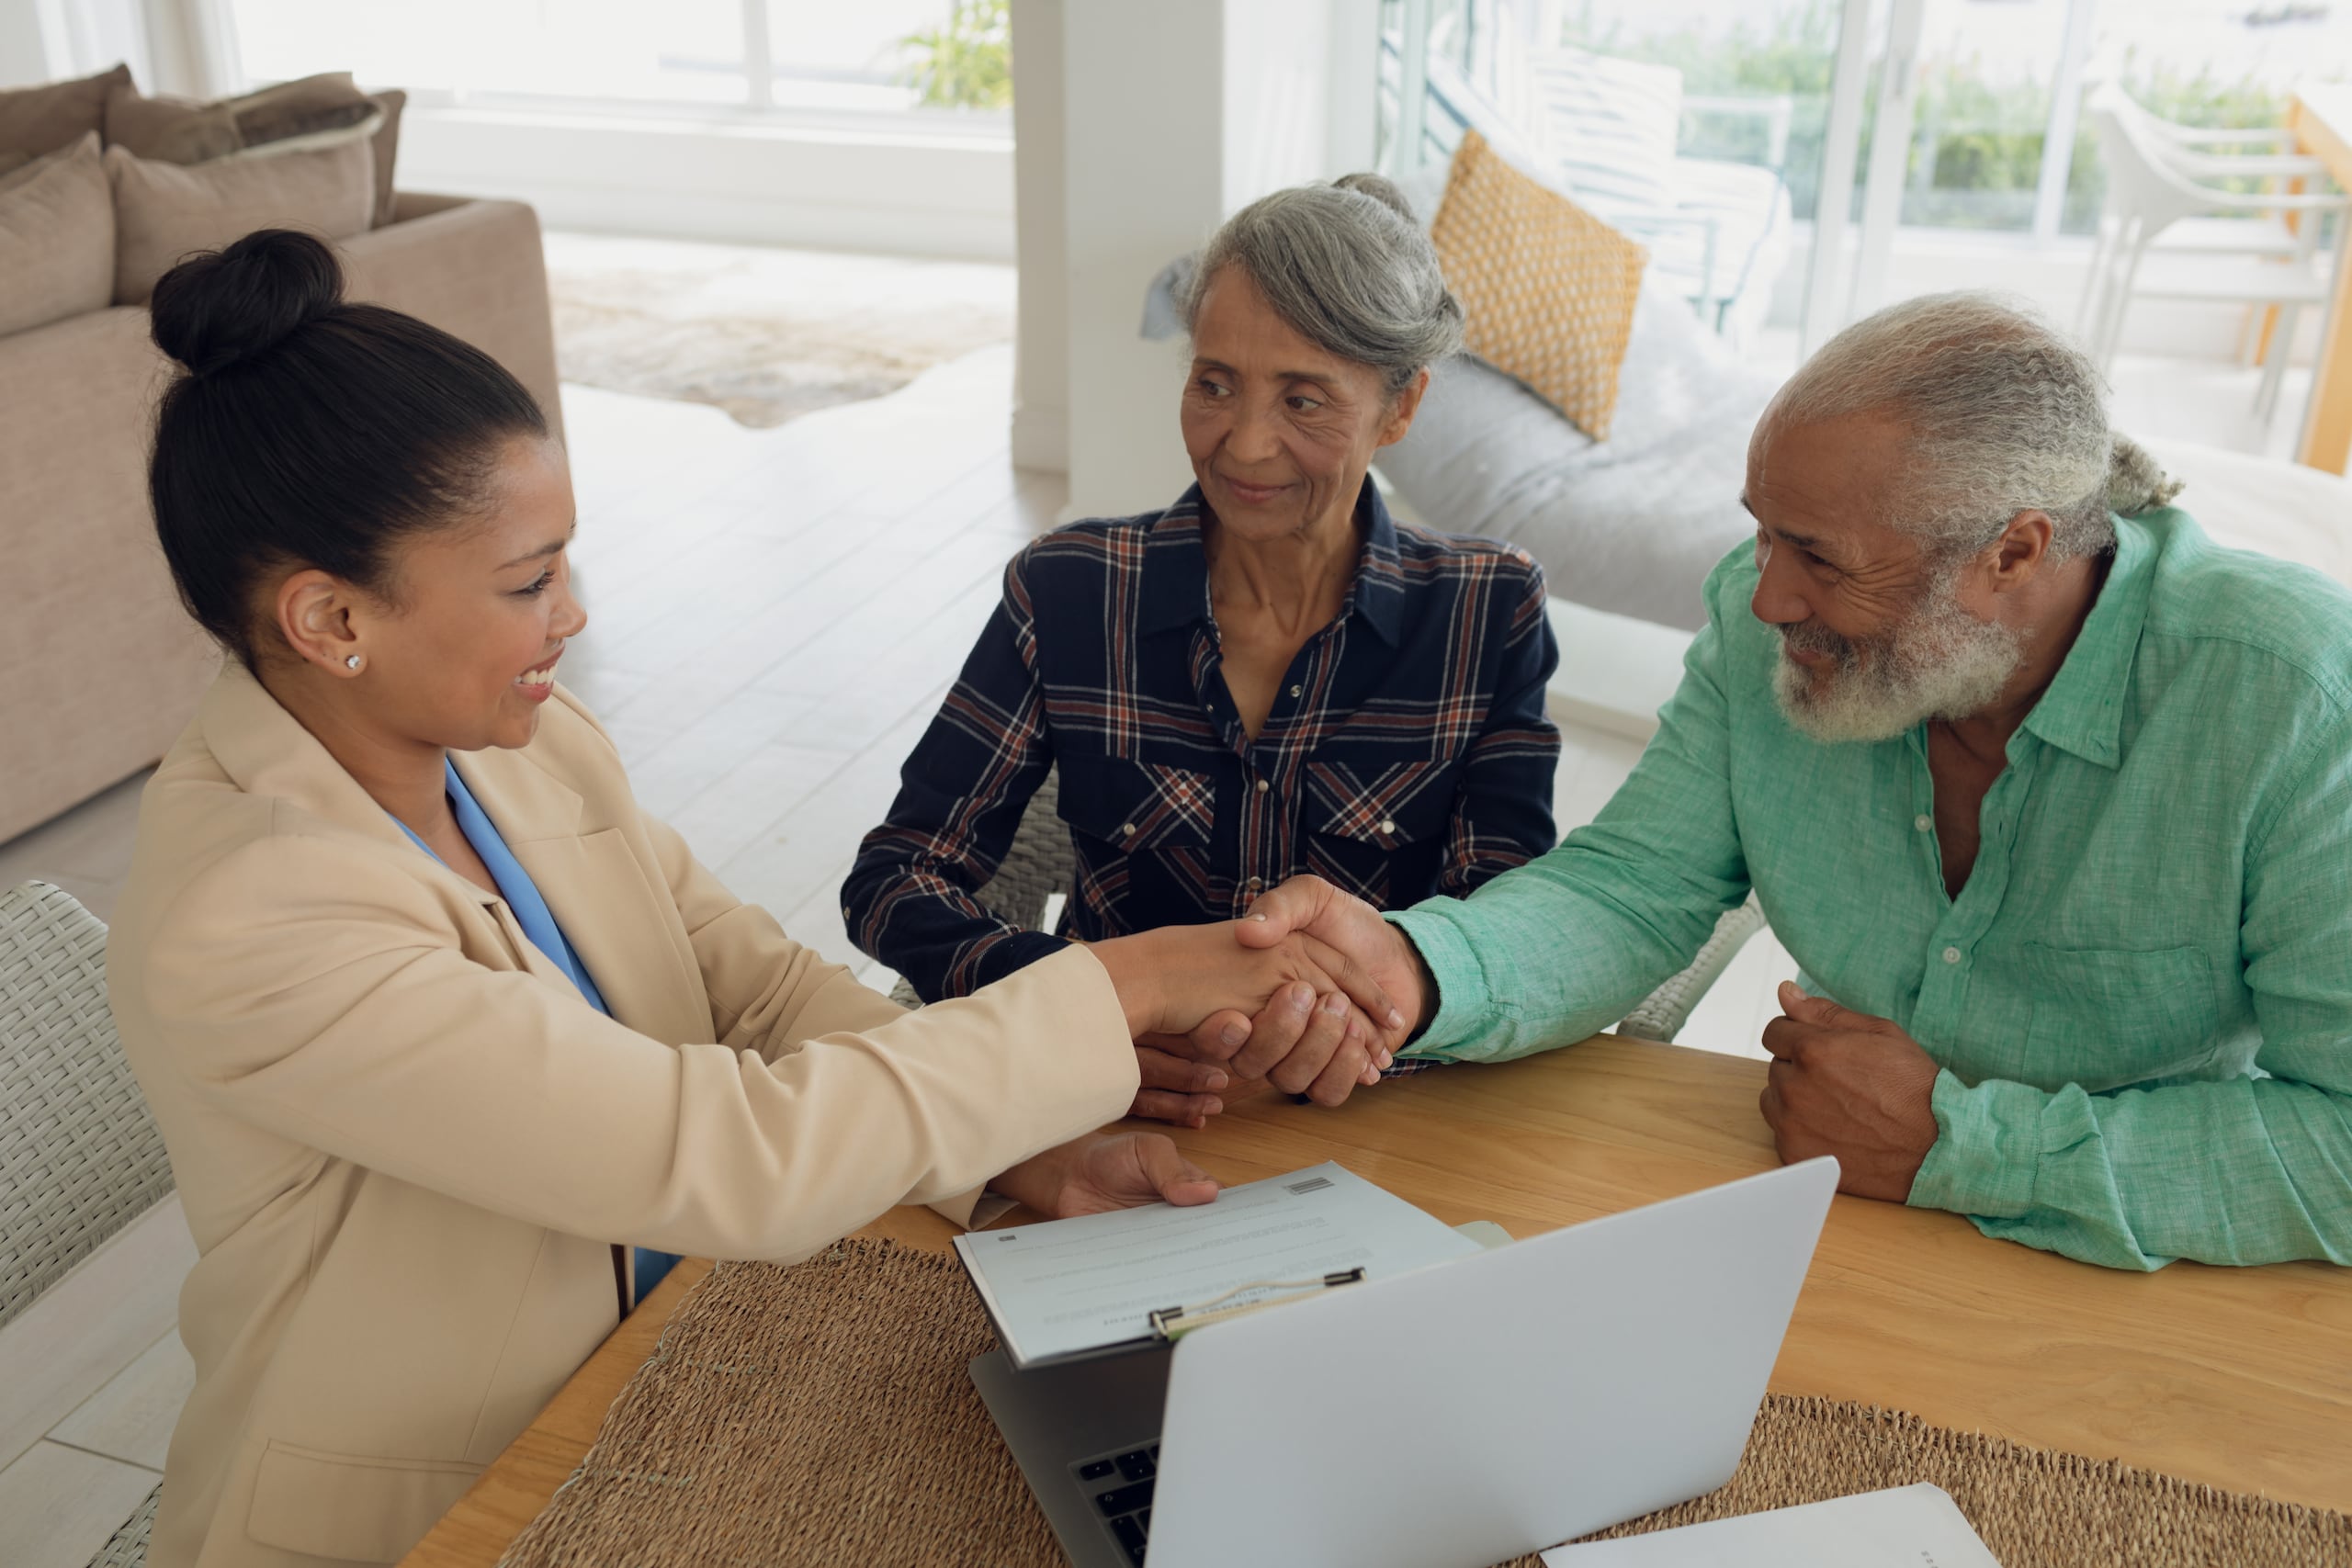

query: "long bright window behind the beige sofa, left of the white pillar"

left=219, top=0, right=1012, bottom=127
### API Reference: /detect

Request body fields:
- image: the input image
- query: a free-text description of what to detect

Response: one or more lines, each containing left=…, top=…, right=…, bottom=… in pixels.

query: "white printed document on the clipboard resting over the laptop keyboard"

left=955, top=1161, right=1479, bottom=1368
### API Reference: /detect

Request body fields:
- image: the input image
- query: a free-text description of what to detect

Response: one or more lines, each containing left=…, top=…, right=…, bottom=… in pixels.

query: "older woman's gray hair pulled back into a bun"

left=1179, top=174, right=1463, bottom=398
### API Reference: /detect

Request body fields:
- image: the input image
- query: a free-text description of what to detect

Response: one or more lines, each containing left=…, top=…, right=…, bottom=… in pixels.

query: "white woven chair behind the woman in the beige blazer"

left=0, top=882, right=172, bottom=1568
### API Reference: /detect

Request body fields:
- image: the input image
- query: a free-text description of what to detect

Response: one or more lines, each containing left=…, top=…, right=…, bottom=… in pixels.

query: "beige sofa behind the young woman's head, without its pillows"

left=0, top=193, right=562, bottom=840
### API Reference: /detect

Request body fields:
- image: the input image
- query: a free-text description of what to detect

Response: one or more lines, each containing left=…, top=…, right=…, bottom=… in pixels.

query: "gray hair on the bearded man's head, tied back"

left=1764, top=291, right=2180, bottom=559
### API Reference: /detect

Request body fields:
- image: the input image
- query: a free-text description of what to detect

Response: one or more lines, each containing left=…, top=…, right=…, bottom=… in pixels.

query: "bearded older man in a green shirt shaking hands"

left=1244, top=294, right=2352, bottom=1269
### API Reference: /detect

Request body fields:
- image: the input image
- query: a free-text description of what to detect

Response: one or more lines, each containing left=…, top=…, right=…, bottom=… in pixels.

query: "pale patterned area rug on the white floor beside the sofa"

left=546, top=232, right=1013, bottom=430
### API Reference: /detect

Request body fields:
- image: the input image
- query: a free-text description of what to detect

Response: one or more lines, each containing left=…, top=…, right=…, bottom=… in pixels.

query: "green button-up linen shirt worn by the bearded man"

left=1390, top=510, right=2352, bottom=1269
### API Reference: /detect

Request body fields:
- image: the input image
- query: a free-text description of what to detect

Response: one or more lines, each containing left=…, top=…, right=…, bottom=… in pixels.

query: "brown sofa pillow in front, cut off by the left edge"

left=0, top=131, right=115, bottom=333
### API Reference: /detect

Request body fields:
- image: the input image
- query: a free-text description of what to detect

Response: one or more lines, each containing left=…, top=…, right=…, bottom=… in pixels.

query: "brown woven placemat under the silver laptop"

left=501, top=1241, right=2352, bottom=1568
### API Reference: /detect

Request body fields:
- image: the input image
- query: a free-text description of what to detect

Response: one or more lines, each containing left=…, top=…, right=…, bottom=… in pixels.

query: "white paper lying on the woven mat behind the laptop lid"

left=1543, top=1485, right=2002, bottom=1568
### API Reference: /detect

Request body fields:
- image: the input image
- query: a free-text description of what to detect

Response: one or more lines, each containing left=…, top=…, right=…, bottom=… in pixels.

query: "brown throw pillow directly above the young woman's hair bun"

left=106, top=141, right=377, bottom=306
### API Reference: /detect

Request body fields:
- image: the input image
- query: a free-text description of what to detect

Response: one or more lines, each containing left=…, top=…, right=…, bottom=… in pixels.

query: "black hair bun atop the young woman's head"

left=148, top=228, right=344, bottom=376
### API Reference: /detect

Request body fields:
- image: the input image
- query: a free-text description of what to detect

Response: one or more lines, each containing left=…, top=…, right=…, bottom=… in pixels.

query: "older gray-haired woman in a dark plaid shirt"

left=842, top=174, right=1559, bottom=1126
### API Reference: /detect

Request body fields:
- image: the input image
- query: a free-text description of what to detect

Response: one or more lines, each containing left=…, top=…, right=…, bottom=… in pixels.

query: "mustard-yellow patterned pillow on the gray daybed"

left=1430, top=131, right=1649, bottom=442
